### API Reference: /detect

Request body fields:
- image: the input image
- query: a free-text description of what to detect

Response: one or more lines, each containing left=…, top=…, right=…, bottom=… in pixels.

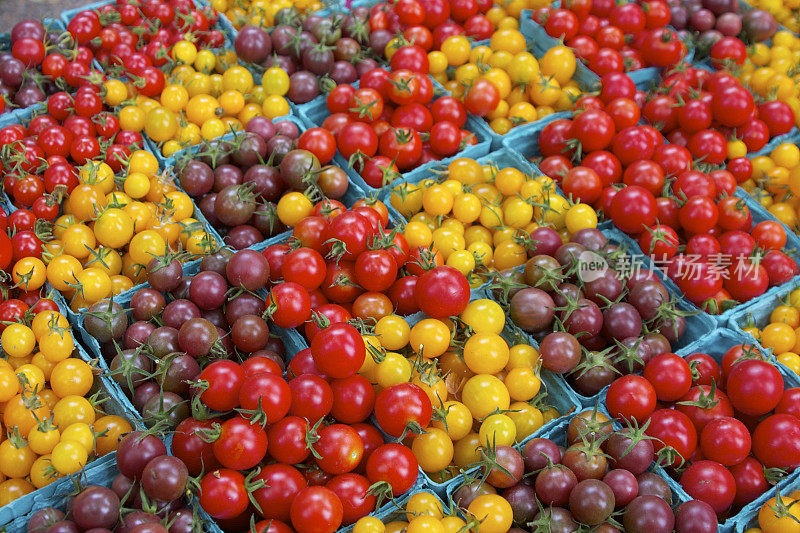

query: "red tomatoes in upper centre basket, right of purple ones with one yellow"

left=318, top=61, right=482, bottom=188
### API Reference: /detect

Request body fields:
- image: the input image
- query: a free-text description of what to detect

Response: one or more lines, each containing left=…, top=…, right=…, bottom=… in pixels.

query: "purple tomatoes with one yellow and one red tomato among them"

left=177, top=121, right=360, bottom=250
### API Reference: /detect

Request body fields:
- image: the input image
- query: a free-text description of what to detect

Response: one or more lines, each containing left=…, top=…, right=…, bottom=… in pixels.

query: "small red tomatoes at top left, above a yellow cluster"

left=67, top=0, right=225, bottom=97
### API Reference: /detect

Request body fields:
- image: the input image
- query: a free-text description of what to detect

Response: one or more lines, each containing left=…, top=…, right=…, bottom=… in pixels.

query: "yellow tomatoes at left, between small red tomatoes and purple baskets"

left=31, top=150, right=216, bottom=310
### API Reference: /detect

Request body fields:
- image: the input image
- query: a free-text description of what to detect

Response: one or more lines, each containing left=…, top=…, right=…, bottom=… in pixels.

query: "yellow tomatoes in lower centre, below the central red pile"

left=359, top=299, right=558, bottom=480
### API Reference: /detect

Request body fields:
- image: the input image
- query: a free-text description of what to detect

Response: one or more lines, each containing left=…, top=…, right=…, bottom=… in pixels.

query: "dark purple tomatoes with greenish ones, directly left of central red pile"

left=83, top=249, right=285, bottom=427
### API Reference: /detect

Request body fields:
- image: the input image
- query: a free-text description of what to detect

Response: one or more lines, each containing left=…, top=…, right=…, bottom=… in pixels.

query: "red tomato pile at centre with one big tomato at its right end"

left=263, top=200, right=469, bottom=326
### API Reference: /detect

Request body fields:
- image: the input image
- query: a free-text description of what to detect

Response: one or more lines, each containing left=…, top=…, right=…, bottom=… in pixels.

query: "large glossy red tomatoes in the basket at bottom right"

left=606, top=344, right=800, bottom=515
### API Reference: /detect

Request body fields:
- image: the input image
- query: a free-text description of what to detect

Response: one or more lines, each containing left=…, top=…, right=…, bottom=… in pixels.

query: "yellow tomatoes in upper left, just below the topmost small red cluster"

left=119, top=41, right=291, bottom=157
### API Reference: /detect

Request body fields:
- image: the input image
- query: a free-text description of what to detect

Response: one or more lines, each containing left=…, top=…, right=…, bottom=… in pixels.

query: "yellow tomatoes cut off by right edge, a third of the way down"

left=742, top=143, right=800, bottom=228
